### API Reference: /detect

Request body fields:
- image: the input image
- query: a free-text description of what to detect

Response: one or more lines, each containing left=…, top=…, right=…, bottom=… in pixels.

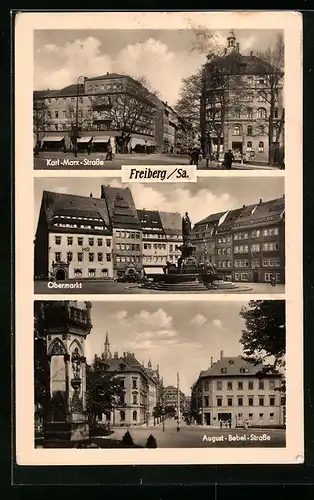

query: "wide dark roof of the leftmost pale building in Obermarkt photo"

left=42, top=191, right=110, bottom=229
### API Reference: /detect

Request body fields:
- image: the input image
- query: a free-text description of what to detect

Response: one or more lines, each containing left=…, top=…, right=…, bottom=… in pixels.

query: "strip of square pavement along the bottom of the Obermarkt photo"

left=34, top=280, right=285, bottom=295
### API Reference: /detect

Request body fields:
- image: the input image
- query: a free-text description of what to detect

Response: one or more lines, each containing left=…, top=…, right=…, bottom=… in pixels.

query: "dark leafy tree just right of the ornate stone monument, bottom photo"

left=86, top=357, right=124, bottom=425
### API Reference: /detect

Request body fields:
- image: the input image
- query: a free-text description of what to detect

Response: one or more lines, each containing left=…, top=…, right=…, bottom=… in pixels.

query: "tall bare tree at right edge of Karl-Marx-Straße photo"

left=258, top=34, right=285, bottom=163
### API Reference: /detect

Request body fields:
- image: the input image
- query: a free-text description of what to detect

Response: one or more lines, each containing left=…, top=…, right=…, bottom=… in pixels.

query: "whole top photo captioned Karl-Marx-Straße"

left=33, top=26, right=285, bottom=170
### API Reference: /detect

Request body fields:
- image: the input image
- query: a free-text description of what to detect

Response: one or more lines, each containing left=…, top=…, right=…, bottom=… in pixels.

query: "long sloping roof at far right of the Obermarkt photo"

left=233, top=198, right=285, bottom=229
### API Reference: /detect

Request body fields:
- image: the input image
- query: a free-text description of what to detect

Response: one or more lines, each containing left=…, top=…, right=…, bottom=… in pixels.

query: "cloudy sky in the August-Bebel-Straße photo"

left=85, top=298, right=248, bottom=395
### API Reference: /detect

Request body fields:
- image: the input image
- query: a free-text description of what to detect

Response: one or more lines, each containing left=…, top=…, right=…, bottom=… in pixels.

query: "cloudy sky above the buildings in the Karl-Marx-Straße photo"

left=34, top=29, right=279, bottom=106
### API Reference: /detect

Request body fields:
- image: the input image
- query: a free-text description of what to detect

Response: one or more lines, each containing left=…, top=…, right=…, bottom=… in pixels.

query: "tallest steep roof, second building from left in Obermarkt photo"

left=101, top=186, right=141, bottom=229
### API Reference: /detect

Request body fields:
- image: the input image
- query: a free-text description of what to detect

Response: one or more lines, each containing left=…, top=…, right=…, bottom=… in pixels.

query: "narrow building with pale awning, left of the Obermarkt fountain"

left=137, top=209, right=168, bottom=275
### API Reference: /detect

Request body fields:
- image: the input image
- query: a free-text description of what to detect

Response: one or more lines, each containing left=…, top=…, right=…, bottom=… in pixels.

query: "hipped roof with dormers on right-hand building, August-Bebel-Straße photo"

left=199, top=356, right=263, bottom=378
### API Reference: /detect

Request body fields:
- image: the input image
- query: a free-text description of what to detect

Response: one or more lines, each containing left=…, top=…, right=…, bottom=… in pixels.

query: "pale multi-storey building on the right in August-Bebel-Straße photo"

left=192, top=351, right=284, bottom=427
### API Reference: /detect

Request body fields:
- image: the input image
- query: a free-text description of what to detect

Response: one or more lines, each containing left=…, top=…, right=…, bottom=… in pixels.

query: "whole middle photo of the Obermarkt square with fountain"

left=34, top=177, right=285, bottom=294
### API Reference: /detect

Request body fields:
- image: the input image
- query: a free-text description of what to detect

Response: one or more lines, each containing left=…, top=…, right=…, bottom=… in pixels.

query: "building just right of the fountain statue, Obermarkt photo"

left=191, top=211, right=228, bottom=264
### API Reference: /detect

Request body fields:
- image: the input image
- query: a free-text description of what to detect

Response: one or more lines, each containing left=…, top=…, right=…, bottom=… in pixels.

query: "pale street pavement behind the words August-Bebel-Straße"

left=99, top=419, right=286, bottom=448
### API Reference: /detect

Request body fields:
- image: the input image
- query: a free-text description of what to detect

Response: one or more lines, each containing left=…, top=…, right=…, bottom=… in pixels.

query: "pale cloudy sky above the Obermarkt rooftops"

left=34, top=177, right=284, bottom=231
